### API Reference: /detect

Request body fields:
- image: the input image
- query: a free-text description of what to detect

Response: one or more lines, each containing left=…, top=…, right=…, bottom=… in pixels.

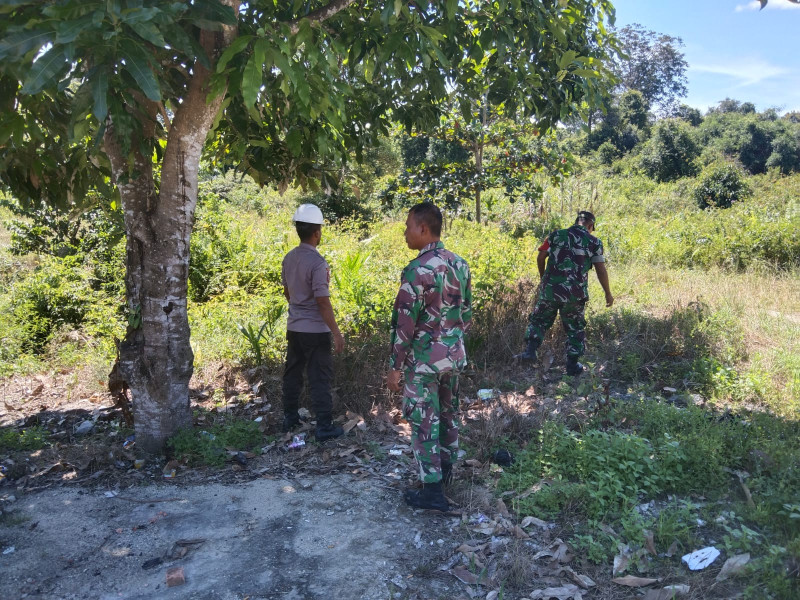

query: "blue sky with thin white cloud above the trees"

left=612, top=0, right=800, bottom=112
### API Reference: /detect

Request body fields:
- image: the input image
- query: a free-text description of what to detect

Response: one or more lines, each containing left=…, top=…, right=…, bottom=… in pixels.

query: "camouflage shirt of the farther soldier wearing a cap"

left=539, top=225, right=606, bottom=302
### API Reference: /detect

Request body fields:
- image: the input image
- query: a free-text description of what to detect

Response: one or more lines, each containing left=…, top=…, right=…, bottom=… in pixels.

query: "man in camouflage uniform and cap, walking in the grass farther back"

left=518, top=211, right=614, bottom=375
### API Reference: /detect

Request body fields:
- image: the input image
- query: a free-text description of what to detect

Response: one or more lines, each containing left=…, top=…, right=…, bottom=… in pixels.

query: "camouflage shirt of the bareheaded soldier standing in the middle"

left=389, top=242, right=472, bottom=373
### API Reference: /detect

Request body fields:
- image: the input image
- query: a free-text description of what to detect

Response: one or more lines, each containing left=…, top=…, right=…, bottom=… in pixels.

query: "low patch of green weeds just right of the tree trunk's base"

left=167, top=419, right=263, bottom=467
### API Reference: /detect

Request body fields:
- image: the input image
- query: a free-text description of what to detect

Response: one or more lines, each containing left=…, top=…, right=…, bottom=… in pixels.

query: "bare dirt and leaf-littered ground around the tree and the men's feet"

left=0, top=371, right=748, bottom=600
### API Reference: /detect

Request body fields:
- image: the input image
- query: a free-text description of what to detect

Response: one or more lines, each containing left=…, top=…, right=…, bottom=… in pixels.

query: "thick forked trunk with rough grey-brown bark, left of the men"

left=104, top=0, right=238, bottom=452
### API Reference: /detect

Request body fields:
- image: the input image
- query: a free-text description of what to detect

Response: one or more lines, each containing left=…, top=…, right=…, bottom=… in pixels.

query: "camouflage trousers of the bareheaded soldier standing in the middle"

left=403, top=371, right=458, bottom=483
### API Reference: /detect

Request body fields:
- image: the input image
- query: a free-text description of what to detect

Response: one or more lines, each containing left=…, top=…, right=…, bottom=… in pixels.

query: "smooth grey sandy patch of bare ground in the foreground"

left=0, top=474, right=468, bottom=600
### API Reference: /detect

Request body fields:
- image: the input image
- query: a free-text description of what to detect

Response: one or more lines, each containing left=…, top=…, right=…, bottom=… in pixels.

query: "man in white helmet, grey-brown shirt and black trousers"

left=281, top=204, right=344, bottom=441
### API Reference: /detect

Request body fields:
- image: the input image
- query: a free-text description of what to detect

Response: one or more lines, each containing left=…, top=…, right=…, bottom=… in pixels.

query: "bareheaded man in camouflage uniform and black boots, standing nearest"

left=387, top=202, right=472, bottom=511
